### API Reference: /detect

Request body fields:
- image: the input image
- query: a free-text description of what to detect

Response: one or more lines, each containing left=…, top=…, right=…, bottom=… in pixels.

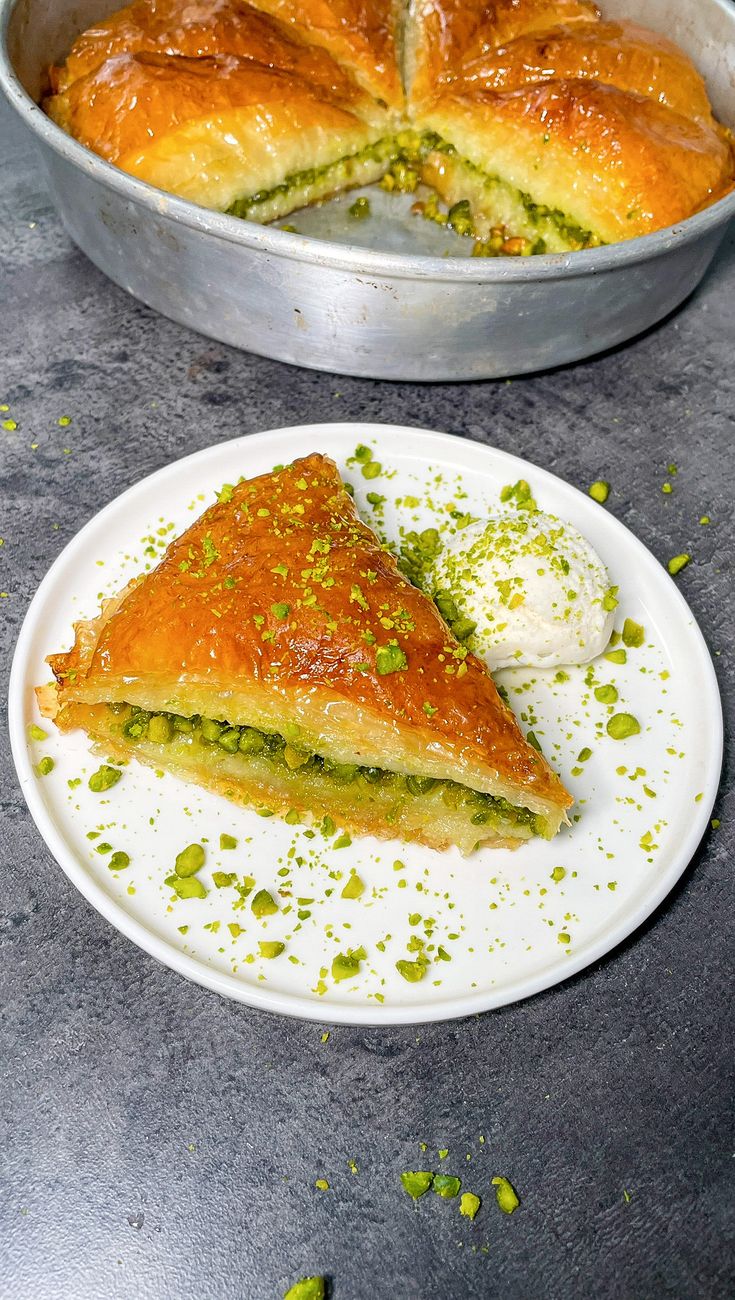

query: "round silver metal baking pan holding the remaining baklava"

left=0, top=0, right=735, bottom=381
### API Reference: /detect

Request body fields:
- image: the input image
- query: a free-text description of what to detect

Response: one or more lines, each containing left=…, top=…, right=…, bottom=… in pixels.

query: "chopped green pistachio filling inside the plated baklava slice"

left=108, top=703, right=549, bottom=841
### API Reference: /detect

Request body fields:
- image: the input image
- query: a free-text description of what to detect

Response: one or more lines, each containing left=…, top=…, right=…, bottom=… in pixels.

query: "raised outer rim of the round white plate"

left=8, top=420, right=723, bottom=1027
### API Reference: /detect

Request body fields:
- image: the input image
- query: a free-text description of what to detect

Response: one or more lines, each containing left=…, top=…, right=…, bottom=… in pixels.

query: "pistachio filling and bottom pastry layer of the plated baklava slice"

left=36, top=685, right=568, bottom=855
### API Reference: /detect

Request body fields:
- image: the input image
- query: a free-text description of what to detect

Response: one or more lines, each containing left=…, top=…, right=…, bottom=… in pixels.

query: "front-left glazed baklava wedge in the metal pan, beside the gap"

left=44, top=48, right=395, bottom=221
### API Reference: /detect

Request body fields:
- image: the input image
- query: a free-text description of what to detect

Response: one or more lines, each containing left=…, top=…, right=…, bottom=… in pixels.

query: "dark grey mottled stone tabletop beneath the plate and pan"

left=0, top=94, right=735, bottom=1300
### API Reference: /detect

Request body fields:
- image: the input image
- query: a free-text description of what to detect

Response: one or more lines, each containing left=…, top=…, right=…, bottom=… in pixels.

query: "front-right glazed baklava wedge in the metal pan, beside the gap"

left=415, top=77, right=732, bottom=254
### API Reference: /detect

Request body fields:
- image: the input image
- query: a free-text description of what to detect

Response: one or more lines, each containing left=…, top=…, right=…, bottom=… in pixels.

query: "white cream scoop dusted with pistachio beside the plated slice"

left=429, top=511, right=617, bottom=670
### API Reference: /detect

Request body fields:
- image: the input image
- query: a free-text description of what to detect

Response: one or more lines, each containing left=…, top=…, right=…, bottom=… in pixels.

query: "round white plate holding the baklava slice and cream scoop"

left=10, top=424, right=722, bottom=1024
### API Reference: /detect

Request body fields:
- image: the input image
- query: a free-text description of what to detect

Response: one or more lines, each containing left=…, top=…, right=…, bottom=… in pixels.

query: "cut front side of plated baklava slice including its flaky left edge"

left=36, top=639, right=572, bottom=854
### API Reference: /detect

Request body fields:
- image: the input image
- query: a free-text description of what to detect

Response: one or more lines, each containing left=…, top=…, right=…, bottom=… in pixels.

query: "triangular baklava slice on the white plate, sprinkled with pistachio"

left=39, top=455, right=572, bottom=853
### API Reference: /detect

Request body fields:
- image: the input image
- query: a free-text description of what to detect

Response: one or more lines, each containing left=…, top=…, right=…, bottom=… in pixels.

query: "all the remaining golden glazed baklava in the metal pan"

left=44, top=0, right=735, bottom=248
